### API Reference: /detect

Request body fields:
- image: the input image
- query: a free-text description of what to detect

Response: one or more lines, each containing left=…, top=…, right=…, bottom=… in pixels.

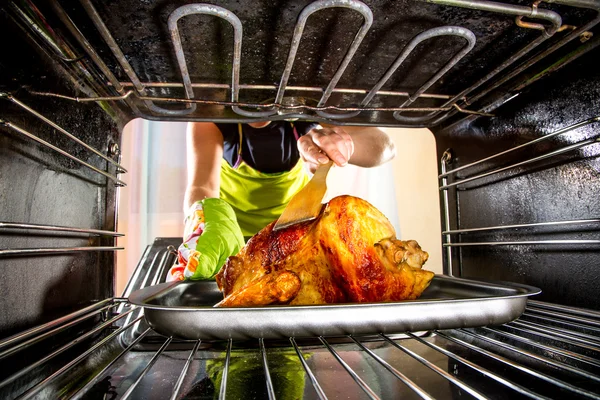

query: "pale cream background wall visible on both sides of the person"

left=117, top=119, right=442, bottom=294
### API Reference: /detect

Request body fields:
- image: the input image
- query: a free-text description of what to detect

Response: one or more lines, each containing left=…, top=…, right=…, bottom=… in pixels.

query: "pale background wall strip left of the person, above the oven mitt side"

left=116, top=119, right=187, bottom=294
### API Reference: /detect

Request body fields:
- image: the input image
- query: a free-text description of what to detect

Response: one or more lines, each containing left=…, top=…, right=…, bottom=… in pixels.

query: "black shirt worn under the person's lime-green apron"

left=216, top=121, right=318, bottom=173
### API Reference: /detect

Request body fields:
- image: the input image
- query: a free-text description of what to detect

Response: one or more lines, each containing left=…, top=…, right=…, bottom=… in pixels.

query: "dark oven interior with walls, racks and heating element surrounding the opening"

left=0, top=0, right=600, bottom=399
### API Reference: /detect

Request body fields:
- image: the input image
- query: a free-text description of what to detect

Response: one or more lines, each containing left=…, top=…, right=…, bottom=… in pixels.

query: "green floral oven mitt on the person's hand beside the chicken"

left=167, top=198, right=244, bottom=281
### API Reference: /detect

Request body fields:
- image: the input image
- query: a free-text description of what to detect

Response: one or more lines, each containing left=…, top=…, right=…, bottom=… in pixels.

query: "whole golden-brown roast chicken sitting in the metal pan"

left=216, top=196, right=434, bottom=307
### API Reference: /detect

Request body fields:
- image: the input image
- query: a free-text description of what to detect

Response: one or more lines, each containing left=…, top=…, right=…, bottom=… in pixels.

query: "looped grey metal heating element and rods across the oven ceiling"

left=5, top=0, right=600, bottom=126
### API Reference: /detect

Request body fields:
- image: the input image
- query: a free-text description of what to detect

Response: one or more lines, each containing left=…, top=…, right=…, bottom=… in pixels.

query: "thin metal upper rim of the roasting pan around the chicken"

left=128, top=274, right=542, bottom=312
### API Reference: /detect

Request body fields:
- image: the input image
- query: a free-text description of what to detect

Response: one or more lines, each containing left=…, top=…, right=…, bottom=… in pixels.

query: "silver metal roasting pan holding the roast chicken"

left=129, top=275, right=541, bottom=340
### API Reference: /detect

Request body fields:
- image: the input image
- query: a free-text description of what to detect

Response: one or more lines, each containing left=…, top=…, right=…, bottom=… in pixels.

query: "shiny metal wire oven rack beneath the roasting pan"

left=0, top=298, right=600, bottom=399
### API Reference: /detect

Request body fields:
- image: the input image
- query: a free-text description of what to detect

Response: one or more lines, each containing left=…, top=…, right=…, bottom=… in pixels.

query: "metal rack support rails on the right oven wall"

left=438, top=116, right=600, bottom=262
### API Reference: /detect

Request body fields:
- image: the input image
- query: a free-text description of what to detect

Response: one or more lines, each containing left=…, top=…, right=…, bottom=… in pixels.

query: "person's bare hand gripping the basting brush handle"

left=298, top=127, right=354, bottom=172
